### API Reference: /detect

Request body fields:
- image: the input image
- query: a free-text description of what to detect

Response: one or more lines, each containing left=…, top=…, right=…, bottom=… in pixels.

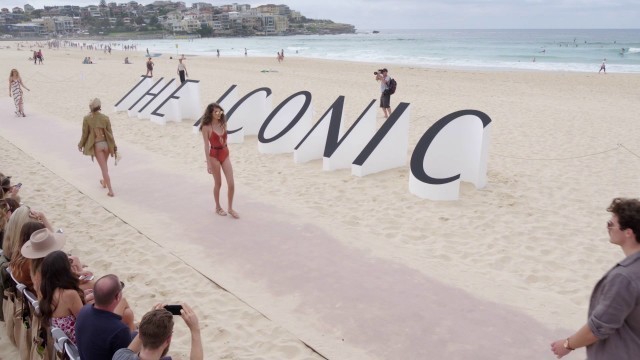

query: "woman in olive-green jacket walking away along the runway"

left=78, top=98, right=118, bottom=196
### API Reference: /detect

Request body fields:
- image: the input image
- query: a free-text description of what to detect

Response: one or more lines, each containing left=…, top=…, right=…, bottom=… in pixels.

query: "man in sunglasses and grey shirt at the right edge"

left=551, top=198, right=640, bottom=360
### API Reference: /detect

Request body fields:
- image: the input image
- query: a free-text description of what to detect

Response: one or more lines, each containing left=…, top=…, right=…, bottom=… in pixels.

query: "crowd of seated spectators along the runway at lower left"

left=0, top=173, right=203, bottom=360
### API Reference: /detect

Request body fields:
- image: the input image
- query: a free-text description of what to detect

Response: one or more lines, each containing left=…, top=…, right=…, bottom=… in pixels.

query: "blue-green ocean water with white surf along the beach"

left=122, top=29, right=640, bottom=73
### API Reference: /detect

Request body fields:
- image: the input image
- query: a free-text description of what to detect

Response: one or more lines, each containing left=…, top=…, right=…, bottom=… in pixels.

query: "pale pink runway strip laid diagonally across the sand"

left=0, top=99, right=568, bottom=360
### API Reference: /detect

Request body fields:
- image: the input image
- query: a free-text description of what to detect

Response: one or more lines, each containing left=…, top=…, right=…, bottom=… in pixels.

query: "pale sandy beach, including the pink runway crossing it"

left=0, top=42, right=640, bottom=359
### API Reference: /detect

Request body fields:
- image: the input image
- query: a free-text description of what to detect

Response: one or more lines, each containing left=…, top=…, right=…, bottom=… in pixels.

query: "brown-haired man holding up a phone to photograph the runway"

left=113, top=304, right=204, bottom=360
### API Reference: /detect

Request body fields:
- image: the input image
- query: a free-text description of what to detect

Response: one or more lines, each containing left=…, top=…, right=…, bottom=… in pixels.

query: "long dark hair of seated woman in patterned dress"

left=40, top=250, right=84, bottom=326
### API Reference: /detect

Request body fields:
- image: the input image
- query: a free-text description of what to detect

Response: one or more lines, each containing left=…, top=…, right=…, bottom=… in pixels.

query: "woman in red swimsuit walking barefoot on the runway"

left=200, top=103, right=240, bottom=219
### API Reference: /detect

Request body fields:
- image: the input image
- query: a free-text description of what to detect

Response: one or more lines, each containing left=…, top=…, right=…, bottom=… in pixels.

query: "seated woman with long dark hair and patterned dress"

left=39, top=250, right=84, bottom=344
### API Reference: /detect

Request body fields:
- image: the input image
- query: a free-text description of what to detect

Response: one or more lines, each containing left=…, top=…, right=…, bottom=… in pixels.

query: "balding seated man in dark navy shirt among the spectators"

left=76, top=274, right=131, bottom=360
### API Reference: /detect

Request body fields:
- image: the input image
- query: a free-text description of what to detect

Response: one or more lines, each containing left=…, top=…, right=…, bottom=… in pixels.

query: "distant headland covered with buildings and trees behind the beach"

left=0, top=0, right=356, bottom=39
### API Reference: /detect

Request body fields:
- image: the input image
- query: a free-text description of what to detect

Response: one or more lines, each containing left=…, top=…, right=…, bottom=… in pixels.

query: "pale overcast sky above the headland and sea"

left=5, top=0, right=640, bottom=30
